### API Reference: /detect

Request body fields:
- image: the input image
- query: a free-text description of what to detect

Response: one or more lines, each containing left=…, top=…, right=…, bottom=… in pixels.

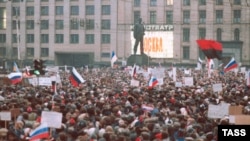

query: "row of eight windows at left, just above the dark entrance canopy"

left=0, top=34, right=110, bottom=44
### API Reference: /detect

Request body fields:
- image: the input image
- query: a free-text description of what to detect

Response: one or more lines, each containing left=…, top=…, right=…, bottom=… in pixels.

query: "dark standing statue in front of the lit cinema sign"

left=134, top=18, right=145, bottom=55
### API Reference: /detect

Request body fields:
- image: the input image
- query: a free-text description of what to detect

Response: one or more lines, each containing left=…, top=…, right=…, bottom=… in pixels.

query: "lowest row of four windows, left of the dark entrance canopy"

left=0, top=47, right=49, bottom=57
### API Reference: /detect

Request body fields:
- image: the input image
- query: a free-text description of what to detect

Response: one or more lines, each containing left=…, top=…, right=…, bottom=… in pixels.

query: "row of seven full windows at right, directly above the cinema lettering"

left=134, top=10, right=241, bottom=24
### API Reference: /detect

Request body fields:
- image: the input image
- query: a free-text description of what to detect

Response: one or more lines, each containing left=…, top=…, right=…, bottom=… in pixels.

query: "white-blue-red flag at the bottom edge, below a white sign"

left=29, top=123, right=50, bottom=141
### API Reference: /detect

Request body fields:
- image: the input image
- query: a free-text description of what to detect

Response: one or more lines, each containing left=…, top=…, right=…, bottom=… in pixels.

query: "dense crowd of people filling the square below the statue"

left=0, top=64, right=250, bottom=141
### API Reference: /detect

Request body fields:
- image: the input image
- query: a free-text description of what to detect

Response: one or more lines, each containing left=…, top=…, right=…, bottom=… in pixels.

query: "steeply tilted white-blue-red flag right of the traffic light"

left=69, top=67, right=85, bottom=87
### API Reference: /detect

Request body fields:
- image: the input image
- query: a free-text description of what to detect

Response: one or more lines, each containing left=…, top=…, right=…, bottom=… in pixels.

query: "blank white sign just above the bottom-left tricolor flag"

left=41, top=111, right=62, bottom=129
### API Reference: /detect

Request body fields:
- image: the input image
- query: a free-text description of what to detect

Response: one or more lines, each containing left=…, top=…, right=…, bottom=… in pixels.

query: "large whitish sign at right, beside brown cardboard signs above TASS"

left=207, top=103, right=230, bottom=118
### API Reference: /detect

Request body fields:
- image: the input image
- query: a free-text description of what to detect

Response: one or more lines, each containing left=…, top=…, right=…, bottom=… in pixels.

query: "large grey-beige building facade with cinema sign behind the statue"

left=0, top=0, right=250, bottom=66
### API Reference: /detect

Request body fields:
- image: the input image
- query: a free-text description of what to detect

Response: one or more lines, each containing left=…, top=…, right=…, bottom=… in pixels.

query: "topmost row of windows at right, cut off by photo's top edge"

left=134, top=0, right=242, bottom=7
